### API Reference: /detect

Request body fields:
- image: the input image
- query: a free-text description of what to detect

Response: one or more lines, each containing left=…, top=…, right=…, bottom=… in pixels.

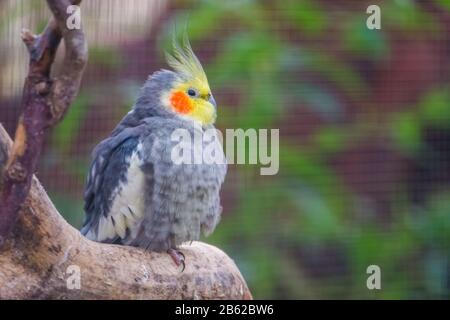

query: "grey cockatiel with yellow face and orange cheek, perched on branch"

left=81, top=36, right=227, bottom=270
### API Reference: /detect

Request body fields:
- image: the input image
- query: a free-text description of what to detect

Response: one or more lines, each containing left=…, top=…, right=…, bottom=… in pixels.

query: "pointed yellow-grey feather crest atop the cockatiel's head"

left=166, top=33, right=208, bottom=83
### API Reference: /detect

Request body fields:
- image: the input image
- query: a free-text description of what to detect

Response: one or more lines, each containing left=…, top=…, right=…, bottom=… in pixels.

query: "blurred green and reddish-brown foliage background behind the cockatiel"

left=1, top=0, right=450, bottom=299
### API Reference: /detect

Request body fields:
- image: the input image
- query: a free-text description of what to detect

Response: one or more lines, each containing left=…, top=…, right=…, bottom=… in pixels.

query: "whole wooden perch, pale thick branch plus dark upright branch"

left=0, top=0, right=251, bottom=299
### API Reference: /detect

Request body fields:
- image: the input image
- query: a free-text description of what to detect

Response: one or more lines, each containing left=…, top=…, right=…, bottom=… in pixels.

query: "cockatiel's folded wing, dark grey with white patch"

left=81, top=127, right=144, bottom=242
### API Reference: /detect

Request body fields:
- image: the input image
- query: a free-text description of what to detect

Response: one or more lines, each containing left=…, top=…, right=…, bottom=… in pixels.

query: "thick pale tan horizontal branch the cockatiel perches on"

left=0, top=125, right=251, bottom=299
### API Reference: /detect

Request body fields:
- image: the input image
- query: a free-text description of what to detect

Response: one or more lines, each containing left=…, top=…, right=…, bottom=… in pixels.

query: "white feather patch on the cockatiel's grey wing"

left=97, top=143, right=145, bottom=241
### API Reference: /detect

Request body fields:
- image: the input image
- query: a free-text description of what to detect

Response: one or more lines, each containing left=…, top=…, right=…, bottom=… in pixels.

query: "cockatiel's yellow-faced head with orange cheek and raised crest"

left=135, top=37, right=216, bottom=127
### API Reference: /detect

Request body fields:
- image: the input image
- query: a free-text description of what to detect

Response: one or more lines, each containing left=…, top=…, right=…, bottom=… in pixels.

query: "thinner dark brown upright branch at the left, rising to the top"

left=0, top=0, right=87, bottom=245
